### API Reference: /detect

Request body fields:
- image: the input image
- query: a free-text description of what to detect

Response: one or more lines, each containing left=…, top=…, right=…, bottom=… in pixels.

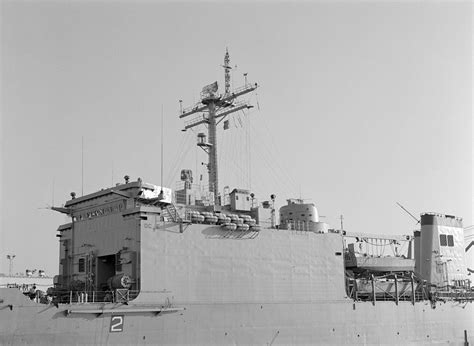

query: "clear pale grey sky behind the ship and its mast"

left=0, top=0, right=473, bottom=275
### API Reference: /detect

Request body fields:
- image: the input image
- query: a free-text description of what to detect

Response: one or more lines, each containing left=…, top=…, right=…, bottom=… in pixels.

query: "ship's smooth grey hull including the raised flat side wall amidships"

left=0, top=220, right=474, bottom=345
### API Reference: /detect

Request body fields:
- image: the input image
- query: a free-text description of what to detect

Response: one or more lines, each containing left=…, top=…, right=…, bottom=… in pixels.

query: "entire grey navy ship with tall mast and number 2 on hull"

left=0, top=50, right=474, bottom=345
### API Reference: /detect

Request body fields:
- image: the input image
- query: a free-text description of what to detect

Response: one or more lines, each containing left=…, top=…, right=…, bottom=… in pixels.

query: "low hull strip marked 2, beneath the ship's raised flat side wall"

left=0, top=289, right=474, bottom=345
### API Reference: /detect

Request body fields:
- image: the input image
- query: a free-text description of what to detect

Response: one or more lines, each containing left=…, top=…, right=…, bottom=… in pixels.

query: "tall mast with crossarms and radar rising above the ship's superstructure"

left=179, top=50, right=257, bottom=205
